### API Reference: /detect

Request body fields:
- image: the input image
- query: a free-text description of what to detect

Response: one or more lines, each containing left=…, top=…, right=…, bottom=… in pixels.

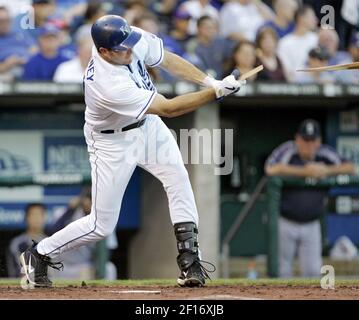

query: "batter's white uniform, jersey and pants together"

left=37, top=28, right=198, bottom=258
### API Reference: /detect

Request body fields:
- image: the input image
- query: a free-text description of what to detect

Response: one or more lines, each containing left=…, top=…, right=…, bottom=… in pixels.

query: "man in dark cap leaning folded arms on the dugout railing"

left=265, top=119, right=354, bottom=278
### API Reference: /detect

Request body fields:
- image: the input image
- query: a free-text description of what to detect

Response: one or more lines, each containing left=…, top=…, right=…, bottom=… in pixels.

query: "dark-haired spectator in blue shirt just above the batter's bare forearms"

left=186, top=16, right=233, bottom=79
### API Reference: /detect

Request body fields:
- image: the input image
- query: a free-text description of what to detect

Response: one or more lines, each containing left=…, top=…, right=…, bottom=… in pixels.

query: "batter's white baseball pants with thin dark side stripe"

left=37, top=115, right=198, bottom=258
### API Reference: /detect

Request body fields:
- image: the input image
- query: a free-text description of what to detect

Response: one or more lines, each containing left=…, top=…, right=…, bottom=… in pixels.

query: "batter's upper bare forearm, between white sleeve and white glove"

left=161, top=51, right=207, bottom=85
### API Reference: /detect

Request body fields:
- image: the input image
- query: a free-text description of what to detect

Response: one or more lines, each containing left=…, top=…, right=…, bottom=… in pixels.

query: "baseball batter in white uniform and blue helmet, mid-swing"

left=20, top=15, right=245, bottom=287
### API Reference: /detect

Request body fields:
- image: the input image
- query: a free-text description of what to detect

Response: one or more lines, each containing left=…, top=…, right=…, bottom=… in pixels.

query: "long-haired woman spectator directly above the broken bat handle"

left=227, top=41, right=257, bottom=82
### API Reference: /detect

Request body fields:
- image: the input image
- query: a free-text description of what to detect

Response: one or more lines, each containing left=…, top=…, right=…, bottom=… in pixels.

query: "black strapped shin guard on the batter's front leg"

left=174, top=222, right=216, bottom=278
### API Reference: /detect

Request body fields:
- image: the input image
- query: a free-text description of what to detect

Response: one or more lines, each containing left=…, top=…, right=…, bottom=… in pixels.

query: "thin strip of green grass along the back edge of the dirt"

left=0, top=279, right=359, bottom=287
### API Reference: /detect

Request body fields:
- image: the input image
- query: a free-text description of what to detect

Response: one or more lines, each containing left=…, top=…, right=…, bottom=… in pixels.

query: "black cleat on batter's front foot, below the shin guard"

left=177, top=259, right=216, bottom=287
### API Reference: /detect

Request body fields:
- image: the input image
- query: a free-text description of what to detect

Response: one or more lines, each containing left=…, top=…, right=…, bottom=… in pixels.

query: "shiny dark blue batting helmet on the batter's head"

left=91, top=15, right=141, bottom=50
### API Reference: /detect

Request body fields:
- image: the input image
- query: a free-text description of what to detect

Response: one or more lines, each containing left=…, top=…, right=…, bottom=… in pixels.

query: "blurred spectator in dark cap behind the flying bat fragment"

left=295, top=47, right=335, bottom=84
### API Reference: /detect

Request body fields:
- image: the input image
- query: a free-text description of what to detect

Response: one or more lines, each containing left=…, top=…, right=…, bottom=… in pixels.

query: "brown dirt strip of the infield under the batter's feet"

left=0, top=283, right=359, bottom=300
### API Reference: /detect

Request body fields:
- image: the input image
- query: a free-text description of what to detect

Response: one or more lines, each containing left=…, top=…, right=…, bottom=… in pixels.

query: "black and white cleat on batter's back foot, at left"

left=20, top=241, right=64, bottom=288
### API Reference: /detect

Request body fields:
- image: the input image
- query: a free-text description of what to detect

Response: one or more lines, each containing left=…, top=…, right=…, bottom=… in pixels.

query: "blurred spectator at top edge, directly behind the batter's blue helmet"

left=71, top=0, right=107, bottom=38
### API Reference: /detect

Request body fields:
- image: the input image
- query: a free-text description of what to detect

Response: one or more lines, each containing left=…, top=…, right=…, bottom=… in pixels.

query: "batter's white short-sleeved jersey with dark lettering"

left=84, top=27, right=163, bottom=130
